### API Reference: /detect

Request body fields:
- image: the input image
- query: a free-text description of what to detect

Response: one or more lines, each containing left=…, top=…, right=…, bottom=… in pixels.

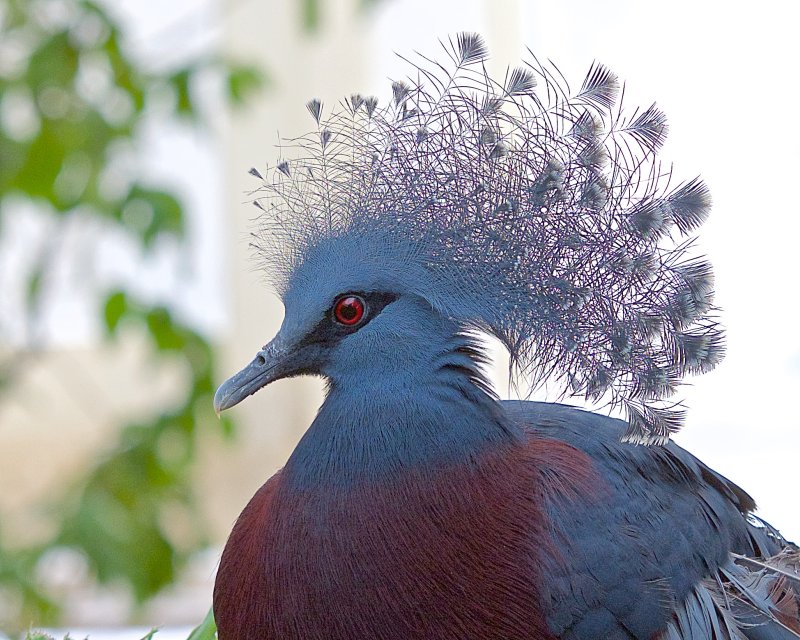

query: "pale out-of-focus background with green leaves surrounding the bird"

left=0, top=0, right=800, bottom=638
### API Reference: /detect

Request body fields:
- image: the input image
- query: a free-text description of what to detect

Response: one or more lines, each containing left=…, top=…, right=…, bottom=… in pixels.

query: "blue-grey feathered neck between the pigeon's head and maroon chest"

left=284, top=368, right=522, bottom=488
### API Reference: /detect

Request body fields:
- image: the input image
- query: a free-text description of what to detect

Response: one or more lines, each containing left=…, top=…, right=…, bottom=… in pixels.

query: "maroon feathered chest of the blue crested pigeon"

left=215, top=448, right=560, bottom=640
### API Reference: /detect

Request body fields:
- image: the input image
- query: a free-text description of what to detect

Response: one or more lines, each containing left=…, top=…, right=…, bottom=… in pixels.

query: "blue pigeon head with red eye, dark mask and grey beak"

left=214, top=230, right=476, bottom=412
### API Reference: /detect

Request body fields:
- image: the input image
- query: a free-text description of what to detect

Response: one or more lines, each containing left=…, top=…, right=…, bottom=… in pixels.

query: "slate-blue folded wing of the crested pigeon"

left=506, top=402, right=800, bottom=640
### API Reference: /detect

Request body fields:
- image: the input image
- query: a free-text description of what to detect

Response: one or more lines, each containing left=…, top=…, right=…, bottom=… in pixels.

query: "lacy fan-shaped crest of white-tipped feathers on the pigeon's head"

left=247, top=34, right=723, bottom=443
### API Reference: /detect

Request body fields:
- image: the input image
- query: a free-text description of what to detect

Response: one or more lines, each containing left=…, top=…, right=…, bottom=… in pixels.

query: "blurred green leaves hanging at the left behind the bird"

left=0, top=0, right=264, bottom=637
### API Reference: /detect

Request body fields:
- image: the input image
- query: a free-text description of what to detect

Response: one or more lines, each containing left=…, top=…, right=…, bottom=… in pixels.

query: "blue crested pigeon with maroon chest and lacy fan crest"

left=213, top=33, right=800, bottom=640
